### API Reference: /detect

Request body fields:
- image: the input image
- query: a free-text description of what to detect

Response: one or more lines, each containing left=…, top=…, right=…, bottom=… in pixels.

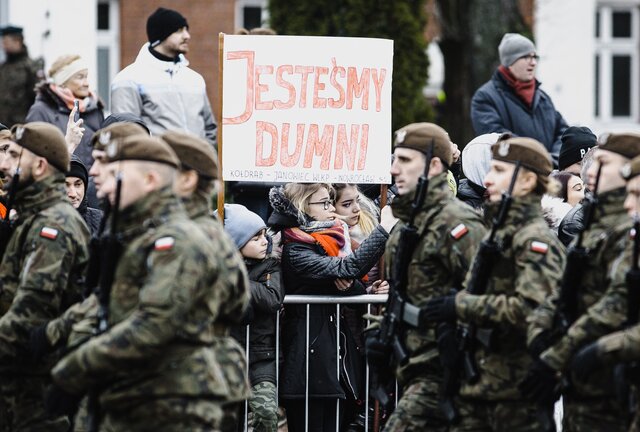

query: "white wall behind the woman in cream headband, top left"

left=7, top=0, right=97, bottom=88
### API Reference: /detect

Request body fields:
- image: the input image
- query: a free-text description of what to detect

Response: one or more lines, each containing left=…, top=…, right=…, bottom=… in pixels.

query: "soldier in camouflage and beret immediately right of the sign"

left=368, top=123, right=485, bottom=432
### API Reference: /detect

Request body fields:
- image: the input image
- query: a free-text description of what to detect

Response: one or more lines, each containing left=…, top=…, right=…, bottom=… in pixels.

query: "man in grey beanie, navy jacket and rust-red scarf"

left=471, top=33, right=567, bottom=166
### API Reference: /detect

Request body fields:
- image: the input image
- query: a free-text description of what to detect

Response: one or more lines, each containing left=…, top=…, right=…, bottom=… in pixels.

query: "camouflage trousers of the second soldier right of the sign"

left=449, top=397, right=552, bottom=432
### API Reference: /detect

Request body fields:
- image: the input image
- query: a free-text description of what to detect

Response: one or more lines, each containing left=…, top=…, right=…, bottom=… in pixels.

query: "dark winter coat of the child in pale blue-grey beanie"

left=231, top=257, right=284, bottom=386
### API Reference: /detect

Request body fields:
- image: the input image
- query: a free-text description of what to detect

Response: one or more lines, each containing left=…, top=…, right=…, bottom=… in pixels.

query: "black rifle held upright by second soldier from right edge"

left=551, top=165, right=602, bottom=334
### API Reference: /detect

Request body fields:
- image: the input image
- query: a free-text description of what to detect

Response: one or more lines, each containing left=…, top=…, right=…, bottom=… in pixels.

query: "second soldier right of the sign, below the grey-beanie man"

left=426, top=138, right=564, bottom=432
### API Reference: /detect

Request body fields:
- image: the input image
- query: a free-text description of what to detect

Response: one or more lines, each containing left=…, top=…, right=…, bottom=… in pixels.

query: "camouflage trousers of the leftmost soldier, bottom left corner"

left=0, top=376, right=69, bottom=432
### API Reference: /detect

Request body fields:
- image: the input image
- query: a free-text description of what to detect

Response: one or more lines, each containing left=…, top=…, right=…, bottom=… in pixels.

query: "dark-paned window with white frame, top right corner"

left=594, top=1, right=640, bottom=122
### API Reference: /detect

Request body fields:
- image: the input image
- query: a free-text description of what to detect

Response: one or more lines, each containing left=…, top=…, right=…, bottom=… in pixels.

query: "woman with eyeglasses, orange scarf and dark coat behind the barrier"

left=269, top=183, right=394, bottom=432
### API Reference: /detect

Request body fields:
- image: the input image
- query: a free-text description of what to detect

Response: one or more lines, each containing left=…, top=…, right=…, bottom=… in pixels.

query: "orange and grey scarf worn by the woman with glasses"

left=283, top=220, right=351, bottom=257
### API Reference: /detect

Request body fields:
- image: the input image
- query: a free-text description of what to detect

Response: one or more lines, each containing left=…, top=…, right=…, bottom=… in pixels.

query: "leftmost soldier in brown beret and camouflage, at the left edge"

left=0, top=122, right=89, bottom=432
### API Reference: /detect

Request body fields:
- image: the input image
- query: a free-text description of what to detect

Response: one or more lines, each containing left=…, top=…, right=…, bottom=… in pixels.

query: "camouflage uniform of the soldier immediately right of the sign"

left=385, top=173, right=486, bottom=431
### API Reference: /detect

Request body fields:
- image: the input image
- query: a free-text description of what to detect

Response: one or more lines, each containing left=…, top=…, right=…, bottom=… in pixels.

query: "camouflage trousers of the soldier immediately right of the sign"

left=384, top=377, right=448, bottom=432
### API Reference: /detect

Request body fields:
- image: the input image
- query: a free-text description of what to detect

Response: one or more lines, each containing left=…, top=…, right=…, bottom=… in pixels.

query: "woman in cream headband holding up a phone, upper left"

left=26, top=55, right=104, bottom=167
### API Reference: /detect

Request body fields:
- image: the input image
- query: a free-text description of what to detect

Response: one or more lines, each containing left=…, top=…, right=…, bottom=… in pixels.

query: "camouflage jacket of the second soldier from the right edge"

left=529, top=188, right=632, bottom=396
